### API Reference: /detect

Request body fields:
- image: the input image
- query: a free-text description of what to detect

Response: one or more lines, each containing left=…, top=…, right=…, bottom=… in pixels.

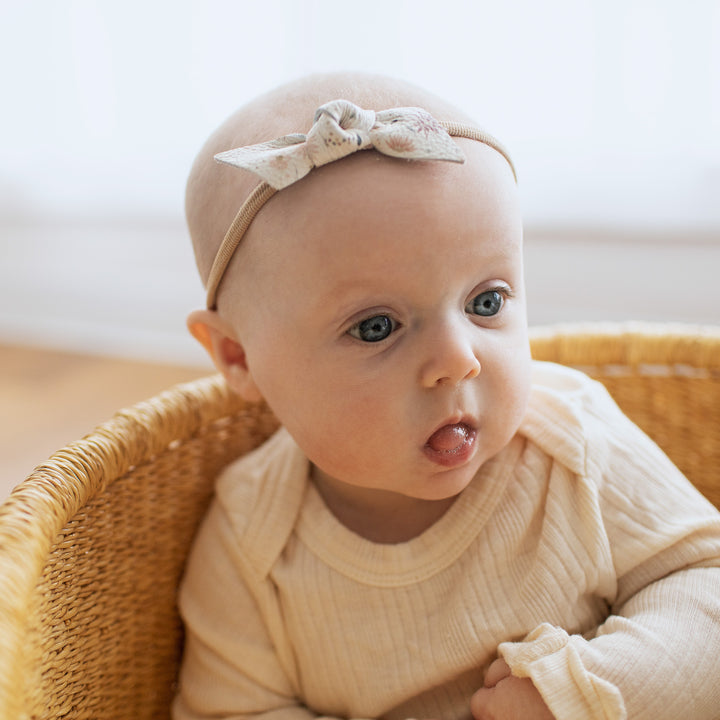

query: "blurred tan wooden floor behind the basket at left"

left=0, top=346, right=213, bottom=501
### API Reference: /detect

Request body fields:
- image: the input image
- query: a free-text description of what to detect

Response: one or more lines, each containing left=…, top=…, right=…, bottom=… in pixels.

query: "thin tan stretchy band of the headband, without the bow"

left=207, top=120, right=517, bottom=310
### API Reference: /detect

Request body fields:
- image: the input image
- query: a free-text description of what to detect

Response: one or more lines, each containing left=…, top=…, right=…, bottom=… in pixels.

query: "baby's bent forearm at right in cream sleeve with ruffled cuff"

left=500, top=568, right=720, bottom=720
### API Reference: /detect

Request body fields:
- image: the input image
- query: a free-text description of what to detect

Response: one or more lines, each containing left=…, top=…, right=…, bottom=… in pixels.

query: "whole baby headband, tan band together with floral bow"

left=207, top=100, right=517, bottom=310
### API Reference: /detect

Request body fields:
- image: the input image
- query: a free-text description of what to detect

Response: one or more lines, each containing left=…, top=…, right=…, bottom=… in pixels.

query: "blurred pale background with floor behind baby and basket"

left=0, top=0, right=720, bottom=490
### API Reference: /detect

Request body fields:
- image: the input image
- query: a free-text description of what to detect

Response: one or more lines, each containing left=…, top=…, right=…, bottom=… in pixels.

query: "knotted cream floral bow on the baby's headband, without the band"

left=215, top=100, right=465, bottom=190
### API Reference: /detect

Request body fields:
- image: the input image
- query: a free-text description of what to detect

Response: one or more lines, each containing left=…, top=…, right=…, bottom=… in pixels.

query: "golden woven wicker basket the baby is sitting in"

left=0, top=325, right=720, bottom=720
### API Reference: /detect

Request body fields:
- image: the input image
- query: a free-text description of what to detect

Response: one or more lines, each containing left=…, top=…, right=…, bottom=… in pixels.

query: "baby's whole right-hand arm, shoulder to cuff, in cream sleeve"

left=492, top=388, right=720, bottom=720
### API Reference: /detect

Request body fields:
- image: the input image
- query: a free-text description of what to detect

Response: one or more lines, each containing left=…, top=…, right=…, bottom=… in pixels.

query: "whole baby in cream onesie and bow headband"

left=174, top=74, right=720, bottom=720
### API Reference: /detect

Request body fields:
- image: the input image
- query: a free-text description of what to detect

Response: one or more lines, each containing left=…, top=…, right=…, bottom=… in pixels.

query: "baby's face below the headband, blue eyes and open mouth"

left=226, top=141, right=530, bottom=500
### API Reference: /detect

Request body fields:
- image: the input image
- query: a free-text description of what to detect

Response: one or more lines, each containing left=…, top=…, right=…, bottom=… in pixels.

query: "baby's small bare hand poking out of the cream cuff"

left=470, top=659, right=553, bottom=720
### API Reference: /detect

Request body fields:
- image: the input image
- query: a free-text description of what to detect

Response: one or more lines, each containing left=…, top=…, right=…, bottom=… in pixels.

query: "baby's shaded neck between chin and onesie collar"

left=310, top=467, right=455, bottom=545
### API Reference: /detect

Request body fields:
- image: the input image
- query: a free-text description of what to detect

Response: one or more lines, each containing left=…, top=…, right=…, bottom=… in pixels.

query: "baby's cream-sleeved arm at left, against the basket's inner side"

left=173, top=504, right=311, bottom=720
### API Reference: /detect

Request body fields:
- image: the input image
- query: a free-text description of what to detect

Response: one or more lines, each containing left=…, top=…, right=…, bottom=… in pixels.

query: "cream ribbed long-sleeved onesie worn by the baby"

left=174, top=363, right=720, bottom=720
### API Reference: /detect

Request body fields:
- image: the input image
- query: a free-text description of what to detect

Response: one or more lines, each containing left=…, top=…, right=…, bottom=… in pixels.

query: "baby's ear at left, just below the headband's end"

left=187, top=310, right=262, bottom=402
